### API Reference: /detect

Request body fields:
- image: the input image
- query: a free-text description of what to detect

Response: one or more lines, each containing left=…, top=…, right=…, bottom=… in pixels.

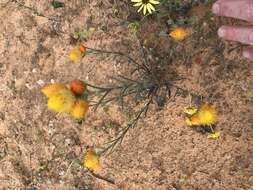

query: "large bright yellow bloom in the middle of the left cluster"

left=47, top=89, right=76, bottom=113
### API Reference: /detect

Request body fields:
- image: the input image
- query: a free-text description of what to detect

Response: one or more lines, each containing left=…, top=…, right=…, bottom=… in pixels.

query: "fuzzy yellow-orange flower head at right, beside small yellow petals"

left=186, top=104, right=218, bottom=126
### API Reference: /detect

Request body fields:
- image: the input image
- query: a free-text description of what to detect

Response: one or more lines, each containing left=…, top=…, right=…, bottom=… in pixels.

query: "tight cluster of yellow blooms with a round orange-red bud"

left=41, top=80, right=89, bottom=119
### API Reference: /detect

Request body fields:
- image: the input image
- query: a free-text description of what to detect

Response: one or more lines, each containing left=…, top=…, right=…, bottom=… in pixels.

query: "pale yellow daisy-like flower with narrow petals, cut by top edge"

left=131, top=0, right=160, bottom=15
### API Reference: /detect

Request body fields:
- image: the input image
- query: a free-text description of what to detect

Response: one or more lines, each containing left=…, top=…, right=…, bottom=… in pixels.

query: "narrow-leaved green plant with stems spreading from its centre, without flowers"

left=67, top=41, right=202, bottom=155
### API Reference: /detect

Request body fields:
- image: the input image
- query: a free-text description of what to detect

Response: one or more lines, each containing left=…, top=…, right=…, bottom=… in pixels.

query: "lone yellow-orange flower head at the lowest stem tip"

left=84, top=149, right=101, bottom=171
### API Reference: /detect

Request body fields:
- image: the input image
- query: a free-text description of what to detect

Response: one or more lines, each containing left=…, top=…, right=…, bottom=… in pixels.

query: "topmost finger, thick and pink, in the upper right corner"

left=212, top=0, right=253, bottom=22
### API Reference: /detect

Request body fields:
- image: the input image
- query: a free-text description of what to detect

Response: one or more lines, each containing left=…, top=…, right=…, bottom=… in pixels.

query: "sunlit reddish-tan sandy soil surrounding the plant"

left=0, top=0, right=253, bottom=190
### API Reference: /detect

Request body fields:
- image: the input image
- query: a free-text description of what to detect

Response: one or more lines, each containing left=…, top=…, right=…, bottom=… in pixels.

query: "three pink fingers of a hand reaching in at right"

left=212, top=0, right=253, bottom=61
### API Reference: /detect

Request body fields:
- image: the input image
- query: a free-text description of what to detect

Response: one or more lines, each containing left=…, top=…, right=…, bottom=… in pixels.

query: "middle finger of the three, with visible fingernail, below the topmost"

left=218, top=26, right=253, bottom=45
